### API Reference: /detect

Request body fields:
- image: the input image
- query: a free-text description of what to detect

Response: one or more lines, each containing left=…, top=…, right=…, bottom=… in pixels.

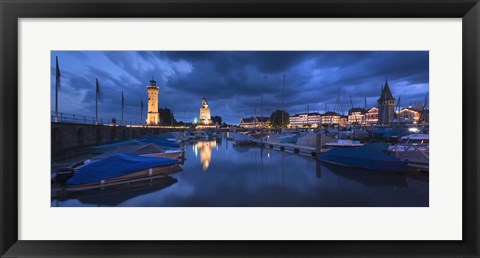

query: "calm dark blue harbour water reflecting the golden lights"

left=52, top=134, right=429, bottom=207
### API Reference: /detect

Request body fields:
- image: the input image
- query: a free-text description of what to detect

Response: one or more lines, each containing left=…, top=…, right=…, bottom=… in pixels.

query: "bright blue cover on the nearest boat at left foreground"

left=65, top=154, right=177, bottom=185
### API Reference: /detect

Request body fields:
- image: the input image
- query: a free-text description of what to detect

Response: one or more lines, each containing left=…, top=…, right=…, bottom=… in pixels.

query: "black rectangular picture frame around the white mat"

left=0, top=0, right=480, bottom=257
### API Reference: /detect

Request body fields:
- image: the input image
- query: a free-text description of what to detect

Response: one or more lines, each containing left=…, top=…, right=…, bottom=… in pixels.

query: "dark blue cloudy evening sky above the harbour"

left=51, top=51, right=429, bottom=124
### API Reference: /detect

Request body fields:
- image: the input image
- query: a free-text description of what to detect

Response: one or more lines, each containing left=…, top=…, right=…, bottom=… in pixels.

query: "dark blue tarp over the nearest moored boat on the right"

left=318, top=148, right=406, bottom=172
